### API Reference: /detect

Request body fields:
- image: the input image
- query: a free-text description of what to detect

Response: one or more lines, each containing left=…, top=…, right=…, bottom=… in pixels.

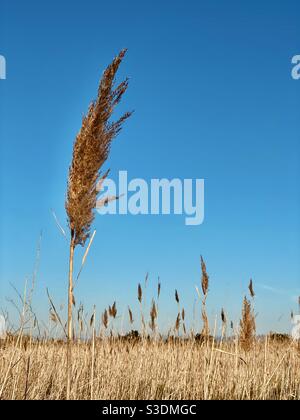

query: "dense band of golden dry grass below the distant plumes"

left=0, top=339, right=300, bottom=400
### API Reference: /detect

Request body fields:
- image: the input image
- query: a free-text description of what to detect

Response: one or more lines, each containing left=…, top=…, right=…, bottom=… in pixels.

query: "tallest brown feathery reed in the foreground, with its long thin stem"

left=65, top=50, right=131, bottom=399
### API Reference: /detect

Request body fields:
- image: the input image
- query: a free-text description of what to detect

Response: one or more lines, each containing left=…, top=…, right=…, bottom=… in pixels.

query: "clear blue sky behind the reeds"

left=0, top=0, right=300, bottom=331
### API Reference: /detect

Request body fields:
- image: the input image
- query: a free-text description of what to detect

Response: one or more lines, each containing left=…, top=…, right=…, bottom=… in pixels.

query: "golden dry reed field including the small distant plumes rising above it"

left=0, top=259, right=300, bottom=400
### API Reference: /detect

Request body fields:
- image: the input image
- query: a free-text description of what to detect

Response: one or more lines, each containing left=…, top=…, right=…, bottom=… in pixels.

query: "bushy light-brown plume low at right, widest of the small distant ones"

left=239, top=296, right=256, bottom=351
